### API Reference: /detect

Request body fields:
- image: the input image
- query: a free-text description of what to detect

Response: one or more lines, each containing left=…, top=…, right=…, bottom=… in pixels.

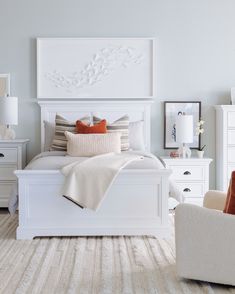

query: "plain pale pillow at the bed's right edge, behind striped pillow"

left=129, top=120, right=145, bottom=151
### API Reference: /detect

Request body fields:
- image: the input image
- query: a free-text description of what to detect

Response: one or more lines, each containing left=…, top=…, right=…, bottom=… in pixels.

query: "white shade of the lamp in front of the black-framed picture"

left=176, top=115, right=193, bottom=143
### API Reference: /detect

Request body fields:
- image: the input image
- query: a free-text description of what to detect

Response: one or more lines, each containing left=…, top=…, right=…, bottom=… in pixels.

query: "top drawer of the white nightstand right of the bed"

left=169, top=165, right=204, bottom=181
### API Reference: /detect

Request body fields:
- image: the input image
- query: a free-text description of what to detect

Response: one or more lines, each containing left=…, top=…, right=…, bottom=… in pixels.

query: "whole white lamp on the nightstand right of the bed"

left=176, top=114, right=193, bottom=158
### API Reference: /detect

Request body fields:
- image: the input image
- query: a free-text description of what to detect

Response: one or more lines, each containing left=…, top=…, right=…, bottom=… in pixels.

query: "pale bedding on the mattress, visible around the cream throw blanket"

left=9, top=151, right=183, bottom=213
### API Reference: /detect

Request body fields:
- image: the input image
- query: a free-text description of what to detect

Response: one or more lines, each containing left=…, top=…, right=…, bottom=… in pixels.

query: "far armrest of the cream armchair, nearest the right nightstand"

left=203, top=190, right=227, bottom=210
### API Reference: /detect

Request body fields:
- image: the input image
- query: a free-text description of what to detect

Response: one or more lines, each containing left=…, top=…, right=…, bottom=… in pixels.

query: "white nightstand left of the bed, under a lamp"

left=0, top=139, right=29, bottom=207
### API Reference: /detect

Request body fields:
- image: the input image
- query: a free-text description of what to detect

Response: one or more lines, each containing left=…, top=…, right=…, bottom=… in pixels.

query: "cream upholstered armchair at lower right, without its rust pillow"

left=175, top=191, right=235, bottom=285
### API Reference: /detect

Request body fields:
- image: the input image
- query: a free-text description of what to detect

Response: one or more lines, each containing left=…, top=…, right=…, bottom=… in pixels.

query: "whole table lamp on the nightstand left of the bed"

left=0, top=96, right=18, bottom=140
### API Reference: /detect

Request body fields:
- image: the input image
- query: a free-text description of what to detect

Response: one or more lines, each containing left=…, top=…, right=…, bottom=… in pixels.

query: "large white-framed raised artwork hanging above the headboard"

left=37, top=38, right=156, bottom=99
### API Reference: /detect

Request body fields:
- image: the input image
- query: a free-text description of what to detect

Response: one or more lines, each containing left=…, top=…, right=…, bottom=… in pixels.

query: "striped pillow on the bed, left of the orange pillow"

left=50, top=114, right=90, bottom=151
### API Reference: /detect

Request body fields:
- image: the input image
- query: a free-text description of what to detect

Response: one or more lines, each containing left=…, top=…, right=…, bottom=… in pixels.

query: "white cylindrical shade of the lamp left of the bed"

left=0, top=96, right=18, bottom=125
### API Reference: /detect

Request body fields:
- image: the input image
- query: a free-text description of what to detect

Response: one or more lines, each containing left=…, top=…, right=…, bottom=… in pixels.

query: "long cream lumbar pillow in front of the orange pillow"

left=65, top=131, right=121, bottom=157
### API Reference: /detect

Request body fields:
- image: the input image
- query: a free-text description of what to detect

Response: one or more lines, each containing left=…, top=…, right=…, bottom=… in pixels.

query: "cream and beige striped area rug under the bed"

left=0, top=213, right=235, bottom=294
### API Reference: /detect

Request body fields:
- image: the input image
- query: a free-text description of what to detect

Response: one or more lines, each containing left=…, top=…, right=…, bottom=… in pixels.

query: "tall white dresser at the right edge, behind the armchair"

left=215, top=105, right=235, bottom=191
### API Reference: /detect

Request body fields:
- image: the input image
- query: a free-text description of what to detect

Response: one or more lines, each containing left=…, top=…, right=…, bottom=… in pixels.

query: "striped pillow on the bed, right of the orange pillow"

left=93, top=115, right=129, bottom=151
